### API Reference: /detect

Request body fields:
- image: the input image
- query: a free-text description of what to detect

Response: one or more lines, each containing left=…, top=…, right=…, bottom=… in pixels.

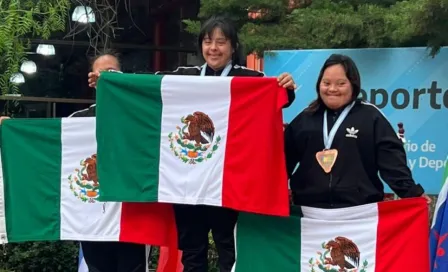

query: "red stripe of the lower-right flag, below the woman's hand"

left=375, top=197, right=430, bottom=272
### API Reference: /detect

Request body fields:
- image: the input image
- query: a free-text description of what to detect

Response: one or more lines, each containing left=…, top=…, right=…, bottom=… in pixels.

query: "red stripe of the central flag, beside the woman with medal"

left=222, top=77, right=289, bottom=216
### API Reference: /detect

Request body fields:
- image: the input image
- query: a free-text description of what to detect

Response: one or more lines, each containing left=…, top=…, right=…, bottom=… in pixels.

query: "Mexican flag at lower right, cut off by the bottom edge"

left=233, top=198, right=429, bottom=272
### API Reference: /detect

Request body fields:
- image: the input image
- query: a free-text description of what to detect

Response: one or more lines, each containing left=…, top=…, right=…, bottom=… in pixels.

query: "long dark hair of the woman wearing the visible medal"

left=306, top=54, right=361, bottom=112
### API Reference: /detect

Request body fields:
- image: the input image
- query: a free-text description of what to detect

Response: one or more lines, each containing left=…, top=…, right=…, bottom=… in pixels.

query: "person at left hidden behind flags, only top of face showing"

left=69, top=52, right=147, bottom=272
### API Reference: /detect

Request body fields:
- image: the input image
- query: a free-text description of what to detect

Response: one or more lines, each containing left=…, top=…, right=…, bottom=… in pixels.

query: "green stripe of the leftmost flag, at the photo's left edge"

left=1, top=119, right=61, bottom=241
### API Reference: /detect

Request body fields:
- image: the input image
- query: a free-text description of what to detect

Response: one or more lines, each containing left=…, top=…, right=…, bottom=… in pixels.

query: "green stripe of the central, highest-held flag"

left=96, top=73, right=163, bottom=201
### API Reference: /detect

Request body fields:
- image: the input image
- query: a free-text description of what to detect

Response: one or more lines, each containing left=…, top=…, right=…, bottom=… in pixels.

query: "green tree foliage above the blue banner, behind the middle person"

left=185, top=0, right=438, bottom=55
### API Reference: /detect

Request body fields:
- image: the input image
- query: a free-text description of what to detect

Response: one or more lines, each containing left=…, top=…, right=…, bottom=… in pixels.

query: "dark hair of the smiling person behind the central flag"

left=198, top=16, right=243, bottom=65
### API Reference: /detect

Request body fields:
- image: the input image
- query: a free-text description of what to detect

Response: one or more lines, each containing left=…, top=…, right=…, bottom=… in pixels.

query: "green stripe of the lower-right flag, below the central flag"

left=235, top=207, right=301, bottom=272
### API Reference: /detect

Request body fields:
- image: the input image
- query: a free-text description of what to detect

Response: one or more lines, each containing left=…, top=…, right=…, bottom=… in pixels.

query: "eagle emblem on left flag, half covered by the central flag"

left=68, top=154, right=100, bottom=203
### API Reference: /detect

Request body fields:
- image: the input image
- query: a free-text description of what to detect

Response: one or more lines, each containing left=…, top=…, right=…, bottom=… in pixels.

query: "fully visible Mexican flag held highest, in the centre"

left=97, top=72, right=289, bottom=216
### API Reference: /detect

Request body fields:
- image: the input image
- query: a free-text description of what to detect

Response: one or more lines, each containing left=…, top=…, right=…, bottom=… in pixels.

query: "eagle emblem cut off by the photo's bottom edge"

left=308, top=236, right=369, bottom=272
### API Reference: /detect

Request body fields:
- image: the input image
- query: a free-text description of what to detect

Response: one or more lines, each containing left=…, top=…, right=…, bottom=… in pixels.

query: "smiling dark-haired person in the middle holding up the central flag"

left=89, top=17, right=296, bottom=272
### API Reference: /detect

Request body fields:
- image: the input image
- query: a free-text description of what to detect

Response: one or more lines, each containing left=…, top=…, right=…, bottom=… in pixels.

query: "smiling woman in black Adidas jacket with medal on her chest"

left=285, top=54, right=430, bottom=208
